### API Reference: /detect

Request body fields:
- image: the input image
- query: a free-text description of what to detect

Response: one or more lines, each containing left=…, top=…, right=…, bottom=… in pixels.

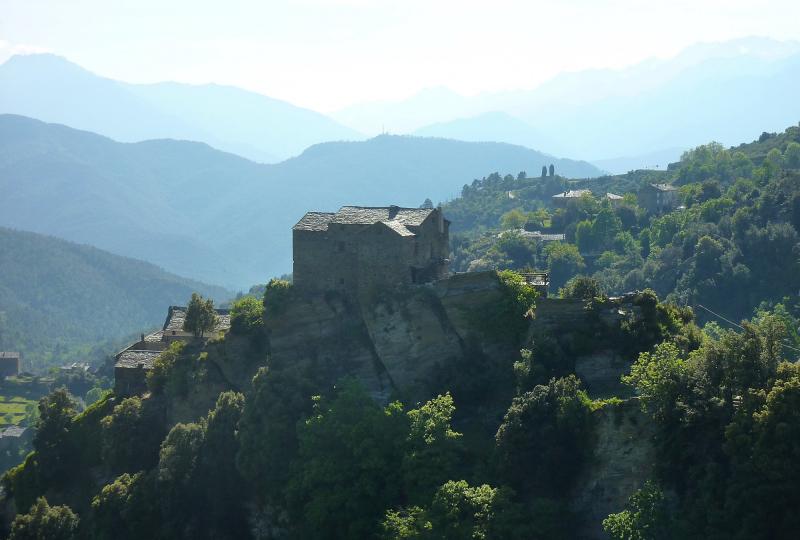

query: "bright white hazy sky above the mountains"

left=0, top=0, right=800, bottom=111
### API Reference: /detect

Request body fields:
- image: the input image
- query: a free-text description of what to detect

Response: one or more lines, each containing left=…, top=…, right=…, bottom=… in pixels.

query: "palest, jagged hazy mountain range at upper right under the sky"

left=332, top=37, right=800, bottom=162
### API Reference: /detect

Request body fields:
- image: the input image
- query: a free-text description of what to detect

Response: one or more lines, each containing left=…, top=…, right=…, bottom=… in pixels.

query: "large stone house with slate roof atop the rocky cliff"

left=292, top=206, right=450, bottom=293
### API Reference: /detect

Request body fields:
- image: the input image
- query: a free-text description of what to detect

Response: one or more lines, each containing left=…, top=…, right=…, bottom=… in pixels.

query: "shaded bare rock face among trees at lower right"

left=571, top=398, right=656, bottom=540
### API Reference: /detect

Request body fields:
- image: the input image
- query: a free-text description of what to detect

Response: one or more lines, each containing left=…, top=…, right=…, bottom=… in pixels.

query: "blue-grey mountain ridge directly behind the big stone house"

left=0, top=115, right=601, bottom=289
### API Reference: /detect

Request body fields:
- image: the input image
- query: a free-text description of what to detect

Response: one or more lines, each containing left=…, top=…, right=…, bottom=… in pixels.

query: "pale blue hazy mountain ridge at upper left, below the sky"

left=0, top=54, right=363, bottom=162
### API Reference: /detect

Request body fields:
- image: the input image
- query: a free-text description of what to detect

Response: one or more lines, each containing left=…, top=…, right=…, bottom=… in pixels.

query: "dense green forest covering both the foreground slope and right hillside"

left=2, top=123, right=800, bottom=540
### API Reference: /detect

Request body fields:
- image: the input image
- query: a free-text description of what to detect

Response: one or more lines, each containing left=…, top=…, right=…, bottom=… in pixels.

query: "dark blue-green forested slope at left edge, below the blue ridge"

left=0, top=228, right=230, bottom=370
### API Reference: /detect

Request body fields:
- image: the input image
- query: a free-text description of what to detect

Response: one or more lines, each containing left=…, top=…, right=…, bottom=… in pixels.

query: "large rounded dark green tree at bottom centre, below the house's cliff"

left=288, top=381, right=408, bottom=539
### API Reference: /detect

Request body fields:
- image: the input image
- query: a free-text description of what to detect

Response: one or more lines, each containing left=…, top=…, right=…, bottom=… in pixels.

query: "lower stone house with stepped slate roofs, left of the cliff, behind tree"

left=114, top=306, right=231, bottom=396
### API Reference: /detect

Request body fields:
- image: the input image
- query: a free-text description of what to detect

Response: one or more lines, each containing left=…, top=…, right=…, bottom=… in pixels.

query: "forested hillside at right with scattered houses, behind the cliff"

left=445, top=126, right=800, bottom=332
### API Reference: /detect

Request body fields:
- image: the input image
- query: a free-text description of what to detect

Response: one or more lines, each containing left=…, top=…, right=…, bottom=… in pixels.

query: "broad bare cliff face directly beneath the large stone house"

left=266, top=272, right=523, bottom=401
